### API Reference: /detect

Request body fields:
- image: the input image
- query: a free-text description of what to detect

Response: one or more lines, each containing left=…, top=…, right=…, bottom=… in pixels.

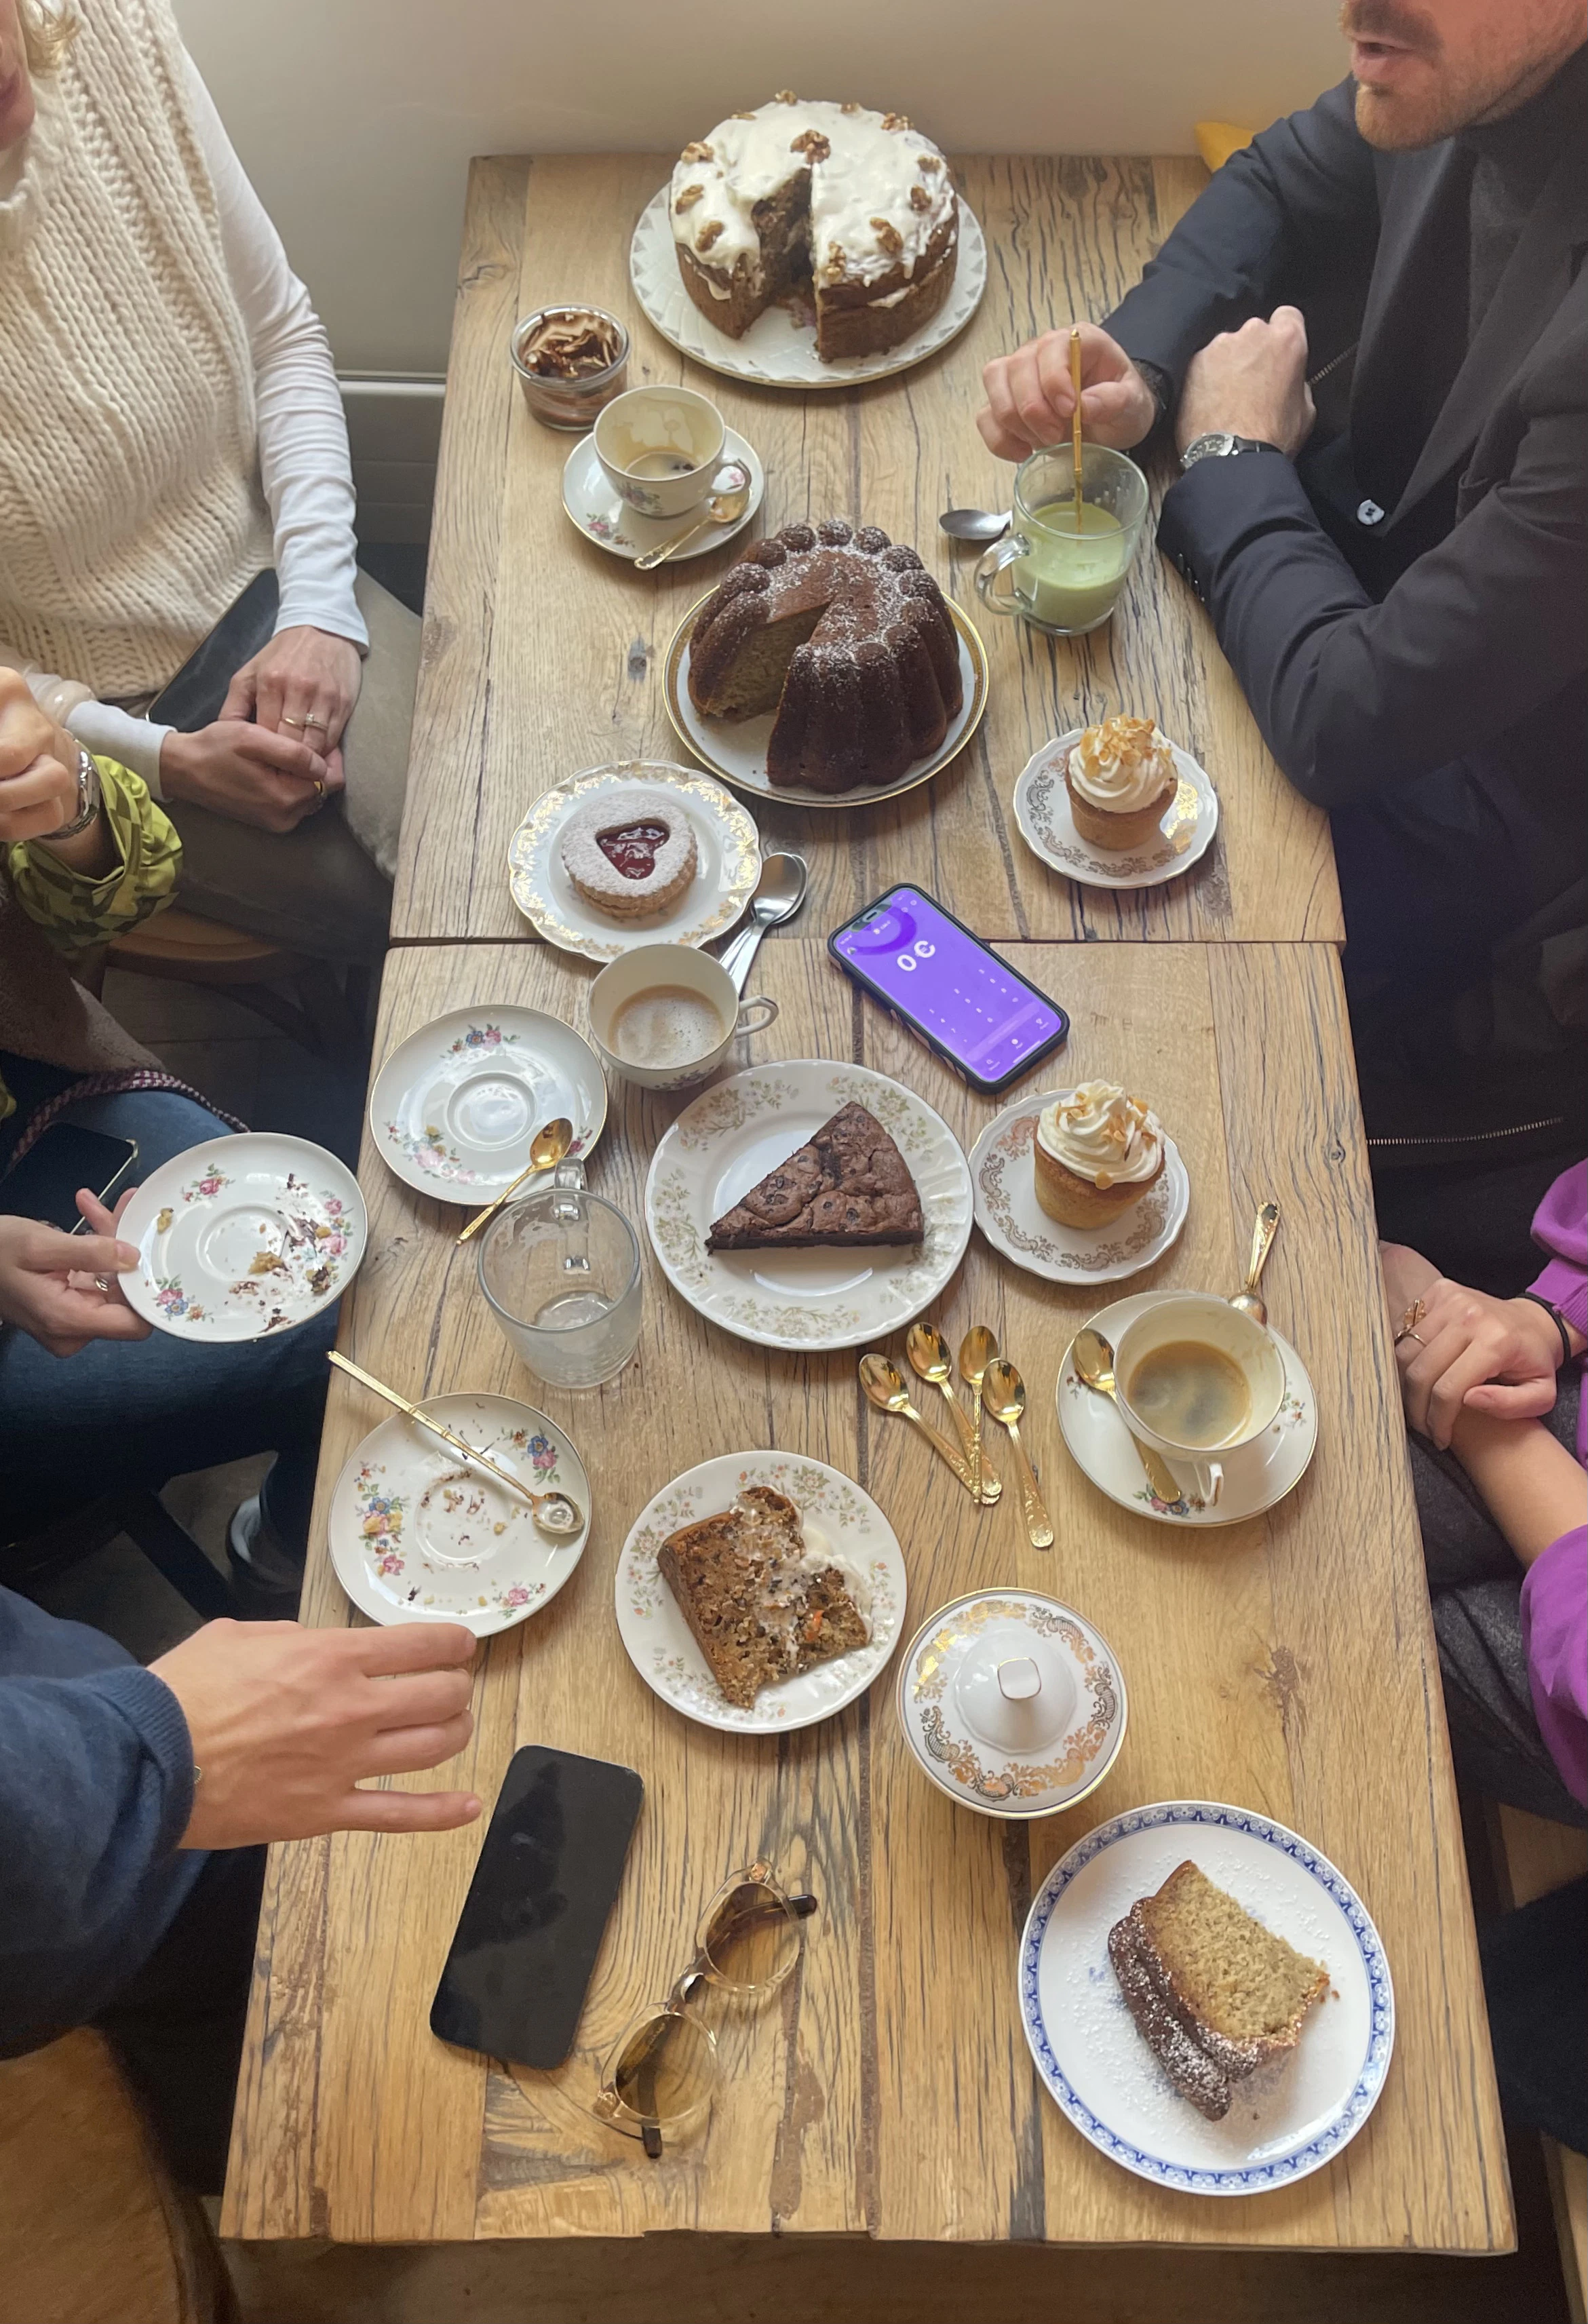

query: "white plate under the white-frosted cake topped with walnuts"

left=627, top=186, right=988, bottom=391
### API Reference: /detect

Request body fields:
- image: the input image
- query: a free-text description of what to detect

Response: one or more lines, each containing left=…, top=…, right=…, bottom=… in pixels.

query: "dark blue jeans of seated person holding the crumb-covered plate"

left=0, top=1058, right=337, bottom=1555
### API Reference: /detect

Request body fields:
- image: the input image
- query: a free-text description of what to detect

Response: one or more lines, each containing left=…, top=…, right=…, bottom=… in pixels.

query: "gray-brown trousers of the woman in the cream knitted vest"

left=165, top=572, right=421, bottom=962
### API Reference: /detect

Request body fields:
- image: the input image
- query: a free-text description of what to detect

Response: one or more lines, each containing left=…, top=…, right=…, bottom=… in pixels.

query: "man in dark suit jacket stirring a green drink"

left=979, top=0, right=1588, bottom=992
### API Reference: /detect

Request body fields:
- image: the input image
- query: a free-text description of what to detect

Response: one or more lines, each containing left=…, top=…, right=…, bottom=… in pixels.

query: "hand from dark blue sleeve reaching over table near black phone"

left=149, top=1622, right=479, bottom=1848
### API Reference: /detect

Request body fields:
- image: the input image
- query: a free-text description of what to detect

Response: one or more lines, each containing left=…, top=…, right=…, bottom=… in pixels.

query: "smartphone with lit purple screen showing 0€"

left=828, top=888, right=1070, bottom=1097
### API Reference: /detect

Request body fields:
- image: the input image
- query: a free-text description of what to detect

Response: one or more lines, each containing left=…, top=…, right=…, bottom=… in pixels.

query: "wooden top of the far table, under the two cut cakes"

left=393, top=153, right=1344, bottom=944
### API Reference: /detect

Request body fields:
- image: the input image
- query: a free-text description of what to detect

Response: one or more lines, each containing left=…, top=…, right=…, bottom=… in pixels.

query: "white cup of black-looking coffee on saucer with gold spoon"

left=1114, top=1292, right=1285, bottom=1508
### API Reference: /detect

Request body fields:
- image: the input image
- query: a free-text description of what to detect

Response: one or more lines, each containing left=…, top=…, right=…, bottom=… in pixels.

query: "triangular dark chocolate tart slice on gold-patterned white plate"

left=707, top=1104, right=925, bottom=1250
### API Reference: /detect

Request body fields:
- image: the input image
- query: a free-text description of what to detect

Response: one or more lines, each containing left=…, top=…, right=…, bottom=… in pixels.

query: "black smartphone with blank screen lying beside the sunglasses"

left=430, top=1743, right=644, bottom=2066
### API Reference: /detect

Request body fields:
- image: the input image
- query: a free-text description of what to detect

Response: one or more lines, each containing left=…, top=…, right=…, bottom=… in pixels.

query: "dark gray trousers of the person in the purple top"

left=1409, top=1374, right=1588, bottom=1827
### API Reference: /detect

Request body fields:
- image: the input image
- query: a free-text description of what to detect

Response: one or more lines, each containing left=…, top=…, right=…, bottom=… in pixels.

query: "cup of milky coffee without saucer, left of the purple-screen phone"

left=591, top=944, right=777, bottom=1090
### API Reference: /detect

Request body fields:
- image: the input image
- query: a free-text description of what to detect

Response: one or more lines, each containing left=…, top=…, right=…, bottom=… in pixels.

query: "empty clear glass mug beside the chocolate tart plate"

left=479, top=1162, right=640, bottom=1387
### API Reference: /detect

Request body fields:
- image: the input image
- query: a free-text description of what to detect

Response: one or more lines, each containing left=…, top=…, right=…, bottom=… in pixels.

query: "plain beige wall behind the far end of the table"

left=176, top=0, right=1344, bottom=372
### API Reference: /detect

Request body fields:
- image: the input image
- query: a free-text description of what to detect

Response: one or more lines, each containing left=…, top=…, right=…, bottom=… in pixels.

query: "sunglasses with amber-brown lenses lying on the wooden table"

left=595, top=1861, right=816, bottom=2156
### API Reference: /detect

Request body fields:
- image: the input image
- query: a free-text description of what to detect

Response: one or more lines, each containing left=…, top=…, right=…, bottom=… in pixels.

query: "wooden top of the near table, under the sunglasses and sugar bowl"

left=223, top=937, right=1513, bottom=2252
